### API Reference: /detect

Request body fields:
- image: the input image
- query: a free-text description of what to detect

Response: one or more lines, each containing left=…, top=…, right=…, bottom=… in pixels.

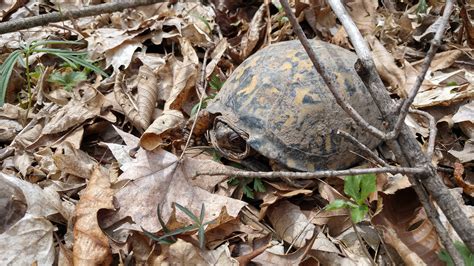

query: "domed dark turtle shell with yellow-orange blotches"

left=207, top=40, right=382, bottom=171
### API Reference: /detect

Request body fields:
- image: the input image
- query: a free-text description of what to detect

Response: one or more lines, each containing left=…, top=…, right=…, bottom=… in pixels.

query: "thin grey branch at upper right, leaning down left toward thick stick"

left=387, top=0, right=453, bottom=139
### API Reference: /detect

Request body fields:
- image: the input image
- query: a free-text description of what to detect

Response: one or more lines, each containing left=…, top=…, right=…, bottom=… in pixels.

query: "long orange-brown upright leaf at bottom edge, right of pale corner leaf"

left=73, top=166, right=114, bottom=265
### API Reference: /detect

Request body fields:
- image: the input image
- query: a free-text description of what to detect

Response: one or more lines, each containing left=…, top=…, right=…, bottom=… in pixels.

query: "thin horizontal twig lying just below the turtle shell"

left=194, top=166, right=428, bottom=179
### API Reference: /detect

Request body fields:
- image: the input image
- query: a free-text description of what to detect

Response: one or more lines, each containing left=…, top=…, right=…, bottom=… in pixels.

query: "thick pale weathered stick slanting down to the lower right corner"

left=328, top=0, right=474, bottom=263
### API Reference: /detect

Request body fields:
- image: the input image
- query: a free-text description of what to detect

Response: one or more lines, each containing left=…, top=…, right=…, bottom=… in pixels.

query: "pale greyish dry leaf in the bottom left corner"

left=0, top=173, right=73, bottom=265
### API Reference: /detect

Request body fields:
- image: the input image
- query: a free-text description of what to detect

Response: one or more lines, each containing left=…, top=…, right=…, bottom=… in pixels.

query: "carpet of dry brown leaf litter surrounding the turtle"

left=0, top=0, right=474, bottom=265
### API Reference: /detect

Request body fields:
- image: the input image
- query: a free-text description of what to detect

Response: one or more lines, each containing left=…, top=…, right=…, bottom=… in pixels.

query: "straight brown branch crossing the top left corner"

left=0, top=0, right=169, bottom=34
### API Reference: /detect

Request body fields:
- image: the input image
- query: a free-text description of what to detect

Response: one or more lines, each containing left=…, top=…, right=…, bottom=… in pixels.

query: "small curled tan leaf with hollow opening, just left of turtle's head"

left=140, top=110, right=185, bottom=151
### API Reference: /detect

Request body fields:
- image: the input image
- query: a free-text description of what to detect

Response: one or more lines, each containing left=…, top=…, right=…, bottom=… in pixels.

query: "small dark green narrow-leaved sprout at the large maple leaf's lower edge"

left=142, top=202, right=214, bottom=249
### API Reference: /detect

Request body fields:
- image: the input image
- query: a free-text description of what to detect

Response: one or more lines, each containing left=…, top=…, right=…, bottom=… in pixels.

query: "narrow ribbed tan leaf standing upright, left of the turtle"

left=137, top=65, right=158, bottom=129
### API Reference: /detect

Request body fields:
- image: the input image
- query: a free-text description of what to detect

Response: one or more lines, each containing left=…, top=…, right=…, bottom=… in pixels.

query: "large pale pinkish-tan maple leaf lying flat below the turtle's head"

left=104, top=149, right=246, bottom=232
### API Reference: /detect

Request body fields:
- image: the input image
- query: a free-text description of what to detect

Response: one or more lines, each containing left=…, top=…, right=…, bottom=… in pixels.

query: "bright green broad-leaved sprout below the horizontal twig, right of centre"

left=325, top=174, right=376, bottom=223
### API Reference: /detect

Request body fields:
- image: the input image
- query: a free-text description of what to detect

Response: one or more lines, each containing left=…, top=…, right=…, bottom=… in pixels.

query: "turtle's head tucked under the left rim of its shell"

left=209, top=116, right=250, bottom=161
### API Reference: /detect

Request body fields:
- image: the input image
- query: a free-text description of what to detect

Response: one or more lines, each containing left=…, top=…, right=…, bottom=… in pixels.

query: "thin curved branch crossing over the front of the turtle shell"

left=280, top=0, right=385, bottom=139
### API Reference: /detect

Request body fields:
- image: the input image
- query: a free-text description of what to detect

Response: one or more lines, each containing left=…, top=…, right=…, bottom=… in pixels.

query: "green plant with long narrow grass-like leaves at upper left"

left=0, top=40, right=108, bottom=107
